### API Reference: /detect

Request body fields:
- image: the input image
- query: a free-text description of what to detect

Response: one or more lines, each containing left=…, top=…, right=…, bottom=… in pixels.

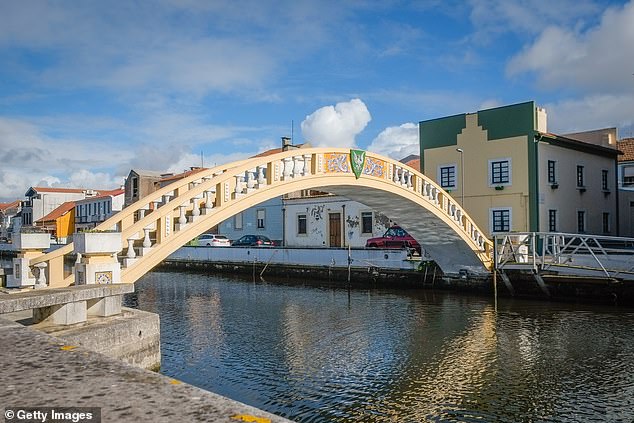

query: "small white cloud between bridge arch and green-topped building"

left=368, top=123, right=420, bottom=160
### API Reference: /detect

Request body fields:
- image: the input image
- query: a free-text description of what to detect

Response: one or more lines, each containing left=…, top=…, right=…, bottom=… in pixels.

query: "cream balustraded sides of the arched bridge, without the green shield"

left=30, top=148, right=492, bottom=286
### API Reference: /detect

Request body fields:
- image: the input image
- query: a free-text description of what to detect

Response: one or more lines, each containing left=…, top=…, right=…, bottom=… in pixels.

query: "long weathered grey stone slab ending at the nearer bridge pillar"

left=0, top=283, right=134, bottom=314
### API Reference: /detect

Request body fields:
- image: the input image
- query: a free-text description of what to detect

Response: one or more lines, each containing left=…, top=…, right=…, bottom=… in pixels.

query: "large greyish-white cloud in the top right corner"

left=507, top=1, right=634, bottom=93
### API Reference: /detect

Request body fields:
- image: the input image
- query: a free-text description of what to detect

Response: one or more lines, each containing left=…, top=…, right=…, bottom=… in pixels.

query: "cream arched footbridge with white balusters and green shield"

left=30, top=148, right=492, bottom=286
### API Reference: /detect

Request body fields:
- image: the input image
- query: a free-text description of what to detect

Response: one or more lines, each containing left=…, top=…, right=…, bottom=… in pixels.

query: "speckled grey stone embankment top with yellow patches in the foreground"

left=0, top=319, right=289, bottom=423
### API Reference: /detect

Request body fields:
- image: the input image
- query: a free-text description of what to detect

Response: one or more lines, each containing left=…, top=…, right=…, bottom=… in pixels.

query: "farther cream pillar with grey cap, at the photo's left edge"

left=7, top=233, right=51, bottom=288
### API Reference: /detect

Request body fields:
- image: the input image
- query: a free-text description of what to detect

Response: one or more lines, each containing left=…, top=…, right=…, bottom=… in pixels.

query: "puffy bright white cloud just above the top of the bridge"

left=301, top=98, right=372, bottom=147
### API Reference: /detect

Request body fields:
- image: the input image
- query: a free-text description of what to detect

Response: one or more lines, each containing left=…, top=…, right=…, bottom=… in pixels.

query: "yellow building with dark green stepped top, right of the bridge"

left=419, top=101, right=619, bottom=236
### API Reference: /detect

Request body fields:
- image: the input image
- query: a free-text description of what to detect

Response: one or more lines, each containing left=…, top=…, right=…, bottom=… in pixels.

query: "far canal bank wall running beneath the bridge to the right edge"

left=158, top=247, right=634, bottom=306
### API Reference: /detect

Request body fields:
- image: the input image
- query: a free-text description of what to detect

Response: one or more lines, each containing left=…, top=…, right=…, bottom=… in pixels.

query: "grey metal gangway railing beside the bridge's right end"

left=493, top=232, right=634, bottom=279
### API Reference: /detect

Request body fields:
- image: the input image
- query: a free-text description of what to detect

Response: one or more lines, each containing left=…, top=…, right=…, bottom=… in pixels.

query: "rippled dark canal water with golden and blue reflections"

left=121, top=271, right=634, bottom=422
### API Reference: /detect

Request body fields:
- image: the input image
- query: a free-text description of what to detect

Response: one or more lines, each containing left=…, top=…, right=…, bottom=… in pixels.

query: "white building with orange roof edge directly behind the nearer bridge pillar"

left=75, top=188, right=125, bottom=232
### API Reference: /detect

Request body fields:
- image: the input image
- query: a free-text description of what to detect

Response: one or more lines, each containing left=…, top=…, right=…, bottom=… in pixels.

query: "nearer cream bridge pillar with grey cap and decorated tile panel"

left=73, top=232, right=121, bottom=285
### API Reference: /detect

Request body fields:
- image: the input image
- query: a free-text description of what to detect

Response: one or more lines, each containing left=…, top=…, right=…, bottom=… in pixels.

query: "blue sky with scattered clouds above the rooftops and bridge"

left=0, top=0, right=634, bottom=201
